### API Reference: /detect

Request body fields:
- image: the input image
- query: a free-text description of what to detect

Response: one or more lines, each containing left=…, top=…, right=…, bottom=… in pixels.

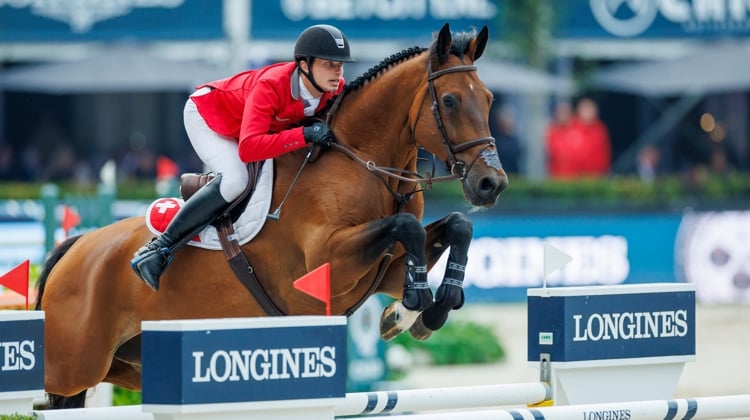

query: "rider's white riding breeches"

left=184, top=88, right=248, bottom=202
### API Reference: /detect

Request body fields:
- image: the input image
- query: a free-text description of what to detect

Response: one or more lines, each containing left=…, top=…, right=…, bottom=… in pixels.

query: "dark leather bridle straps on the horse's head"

left=424, top=62, right=495, bottom=180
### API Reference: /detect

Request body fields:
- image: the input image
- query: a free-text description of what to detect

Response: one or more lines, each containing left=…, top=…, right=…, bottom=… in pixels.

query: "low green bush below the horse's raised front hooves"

left=389, top=320, right=505, bottom=365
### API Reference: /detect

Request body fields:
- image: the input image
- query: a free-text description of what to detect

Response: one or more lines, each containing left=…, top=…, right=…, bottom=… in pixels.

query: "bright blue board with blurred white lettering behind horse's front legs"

left=429, top=214, right=683, bottom=302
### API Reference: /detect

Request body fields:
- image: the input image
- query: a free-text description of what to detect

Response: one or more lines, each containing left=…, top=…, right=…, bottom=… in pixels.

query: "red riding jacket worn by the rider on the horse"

left=192, top=62, right=344, bottom=162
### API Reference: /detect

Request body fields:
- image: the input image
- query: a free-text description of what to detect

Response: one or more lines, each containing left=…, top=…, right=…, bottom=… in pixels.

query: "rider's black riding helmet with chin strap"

left=294, top=25, right=356, bottom=92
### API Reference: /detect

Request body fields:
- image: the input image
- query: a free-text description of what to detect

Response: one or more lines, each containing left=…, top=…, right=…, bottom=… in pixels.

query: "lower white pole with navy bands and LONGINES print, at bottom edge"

left=349, top=395, right=750, bottom=420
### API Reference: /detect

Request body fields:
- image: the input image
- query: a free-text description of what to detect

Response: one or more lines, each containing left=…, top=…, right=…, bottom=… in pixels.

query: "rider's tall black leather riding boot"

left=130, top=174, right=229, bottom=291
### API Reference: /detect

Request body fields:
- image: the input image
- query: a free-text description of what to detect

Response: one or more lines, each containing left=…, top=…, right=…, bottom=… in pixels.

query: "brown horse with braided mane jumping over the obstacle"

left=37, top=23, right=508, bottom=408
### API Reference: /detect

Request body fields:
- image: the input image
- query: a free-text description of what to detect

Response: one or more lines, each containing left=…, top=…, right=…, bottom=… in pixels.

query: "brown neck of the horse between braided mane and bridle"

left=336, top=58, right=425, bottom=169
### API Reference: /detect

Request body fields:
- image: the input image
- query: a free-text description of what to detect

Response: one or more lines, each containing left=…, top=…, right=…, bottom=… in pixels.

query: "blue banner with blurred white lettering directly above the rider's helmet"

left=250, top=0, right=499, bottom=42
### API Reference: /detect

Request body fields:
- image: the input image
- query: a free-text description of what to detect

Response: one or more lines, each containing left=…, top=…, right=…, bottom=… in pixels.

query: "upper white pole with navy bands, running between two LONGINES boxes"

left=335, top=382, right=552, bottom=416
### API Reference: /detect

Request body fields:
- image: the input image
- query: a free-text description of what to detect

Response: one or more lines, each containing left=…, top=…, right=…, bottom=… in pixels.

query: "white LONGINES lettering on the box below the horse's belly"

left=192, top=346, right=336, bottom=382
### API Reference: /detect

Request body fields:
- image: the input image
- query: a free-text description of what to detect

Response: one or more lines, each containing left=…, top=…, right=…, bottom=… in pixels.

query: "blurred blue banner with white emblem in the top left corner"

left=0, top=0, right=224, bottom=42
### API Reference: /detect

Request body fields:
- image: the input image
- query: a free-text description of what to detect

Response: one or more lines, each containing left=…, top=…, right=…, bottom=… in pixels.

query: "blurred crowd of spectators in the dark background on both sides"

left=0, top=96, right=740, bottom=184
